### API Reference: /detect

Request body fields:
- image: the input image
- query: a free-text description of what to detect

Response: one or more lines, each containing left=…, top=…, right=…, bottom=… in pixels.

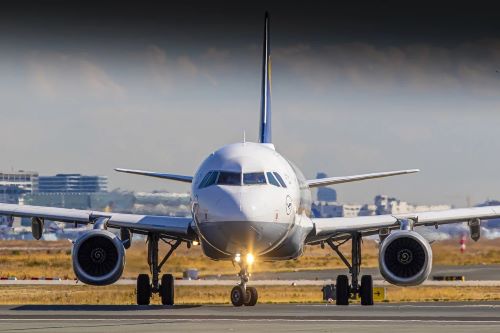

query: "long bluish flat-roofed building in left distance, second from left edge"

left=34, top=174, right=108, bottom=193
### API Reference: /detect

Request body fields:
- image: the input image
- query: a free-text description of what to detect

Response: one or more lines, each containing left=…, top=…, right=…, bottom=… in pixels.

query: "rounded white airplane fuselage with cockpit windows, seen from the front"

left=191, top=142, right=313, bottom=260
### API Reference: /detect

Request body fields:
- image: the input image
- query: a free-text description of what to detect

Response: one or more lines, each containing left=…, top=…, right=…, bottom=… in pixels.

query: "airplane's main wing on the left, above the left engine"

left=0, top=203, right=195, bottom=240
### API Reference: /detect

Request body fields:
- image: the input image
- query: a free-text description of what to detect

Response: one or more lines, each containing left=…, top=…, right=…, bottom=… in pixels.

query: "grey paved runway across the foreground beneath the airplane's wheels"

left=0, top=302, right=500, bottom=333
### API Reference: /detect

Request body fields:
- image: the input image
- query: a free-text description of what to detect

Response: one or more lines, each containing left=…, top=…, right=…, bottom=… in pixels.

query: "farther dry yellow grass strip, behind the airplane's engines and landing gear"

left=0, top=239, right=500, bottom=279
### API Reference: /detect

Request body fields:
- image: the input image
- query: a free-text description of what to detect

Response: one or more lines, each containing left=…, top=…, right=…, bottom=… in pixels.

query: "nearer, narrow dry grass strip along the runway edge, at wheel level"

left=0, top=285, right=500, bottom=304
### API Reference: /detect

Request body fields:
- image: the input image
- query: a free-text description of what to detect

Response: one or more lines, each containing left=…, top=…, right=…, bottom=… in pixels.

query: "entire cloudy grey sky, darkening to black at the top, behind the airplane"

left=0, top=1, right=500, bottom=207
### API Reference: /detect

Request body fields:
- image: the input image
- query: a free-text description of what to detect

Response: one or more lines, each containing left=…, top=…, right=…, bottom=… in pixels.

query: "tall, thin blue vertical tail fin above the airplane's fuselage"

left=259, top=12, right=271, bottom=143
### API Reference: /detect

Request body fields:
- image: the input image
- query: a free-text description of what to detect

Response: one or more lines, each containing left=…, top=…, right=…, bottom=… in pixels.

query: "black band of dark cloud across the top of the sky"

left=0, top=0, right=500, bottom=48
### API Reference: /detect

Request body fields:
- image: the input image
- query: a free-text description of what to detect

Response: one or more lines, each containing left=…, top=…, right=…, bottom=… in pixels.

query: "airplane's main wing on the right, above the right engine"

left=307, top=206, right=500, bottom=243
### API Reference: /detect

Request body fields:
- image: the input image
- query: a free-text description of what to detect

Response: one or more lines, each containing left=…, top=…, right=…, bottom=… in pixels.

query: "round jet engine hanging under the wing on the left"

left=72, top=230, right=125, bottom=286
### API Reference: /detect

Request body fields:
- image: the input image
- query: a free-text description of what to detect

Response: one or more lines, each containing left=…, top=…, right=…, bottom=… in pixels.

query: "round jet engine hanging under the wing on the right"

left=379, top=230, right=432, bottom=286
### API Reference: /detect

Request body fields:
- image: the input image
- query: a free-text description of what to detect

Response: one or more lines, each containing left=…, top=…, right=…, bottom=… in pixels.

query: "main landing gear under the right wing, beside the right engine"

left=327, top=233, right=373, bottom=305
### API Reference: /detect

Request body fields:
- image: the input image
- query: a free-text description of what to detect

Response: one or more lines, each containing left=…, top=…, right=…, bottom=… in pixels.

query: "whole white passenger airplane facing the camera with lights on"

left=0, top=13, right=500, bottom=306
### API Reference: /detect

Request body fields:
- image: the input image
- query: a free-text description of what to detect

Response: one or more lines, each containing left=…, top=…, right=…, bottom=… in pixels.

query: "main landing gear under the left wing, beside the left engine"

left=137, top=233, right=182, bottom=305
